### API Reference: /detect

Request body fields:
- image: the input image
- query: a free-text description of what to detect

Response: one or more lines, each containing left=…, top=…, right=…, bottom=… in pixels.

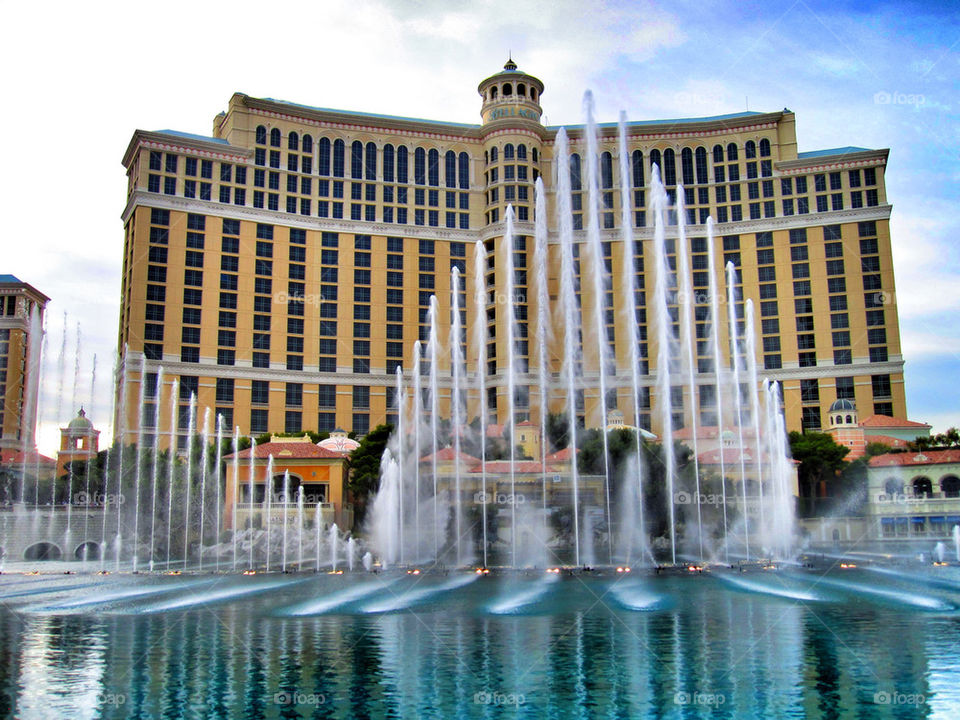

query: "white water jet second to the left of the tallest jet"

left=533, top=177, right=553, bottom=542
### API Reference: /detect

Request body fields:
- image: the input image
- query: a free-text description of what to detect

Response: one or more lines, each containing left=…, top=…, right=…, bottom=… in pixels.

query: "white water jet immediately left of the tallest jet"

left=556, top=128, right=580, bottom=565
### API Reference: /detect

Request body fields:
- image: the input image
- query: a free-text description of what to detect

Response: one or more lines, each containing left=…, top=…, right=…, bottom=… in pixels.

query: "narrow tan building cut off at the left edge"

left=0, top=275, right=50, bottom=452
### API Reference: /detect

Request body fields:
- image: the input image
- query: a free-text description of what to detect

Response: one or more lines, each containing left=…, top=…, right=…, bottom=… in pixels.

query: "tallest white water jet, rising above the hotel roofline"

left=583, top=90, right=613, bottom=564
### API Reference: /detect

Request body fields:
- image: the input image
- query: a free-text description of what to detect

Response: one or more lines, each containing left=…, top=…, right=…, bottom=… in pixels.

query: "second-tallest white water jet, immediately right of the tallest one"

left=619, top=113, right=647, bottom=562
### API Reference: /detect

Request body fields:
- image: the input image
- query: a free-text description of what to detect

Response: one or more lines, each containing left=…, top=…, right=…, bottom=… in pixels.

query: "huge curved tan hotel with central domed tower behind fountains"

left=116, top=61, right=906, bottom=447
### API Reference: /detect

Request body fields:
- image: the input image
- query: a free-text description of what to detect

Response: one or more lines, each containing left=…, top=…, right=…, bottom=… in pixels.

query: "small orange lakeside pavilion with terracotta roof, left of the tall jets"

left=223, top=436, right=353, bottom=528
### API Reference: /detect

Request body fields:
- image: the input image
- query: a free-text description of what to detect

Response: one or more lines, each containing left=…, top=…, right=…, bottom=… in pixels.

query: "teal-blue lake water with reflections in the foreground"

left=0, top=568, right=960, bottom=720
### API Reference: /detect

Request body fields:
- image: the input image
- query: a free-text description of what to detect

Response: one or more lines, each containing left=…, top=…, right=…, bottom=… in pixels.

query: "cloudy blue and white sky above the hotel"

left=0, top=0, right=960, bottom=451
